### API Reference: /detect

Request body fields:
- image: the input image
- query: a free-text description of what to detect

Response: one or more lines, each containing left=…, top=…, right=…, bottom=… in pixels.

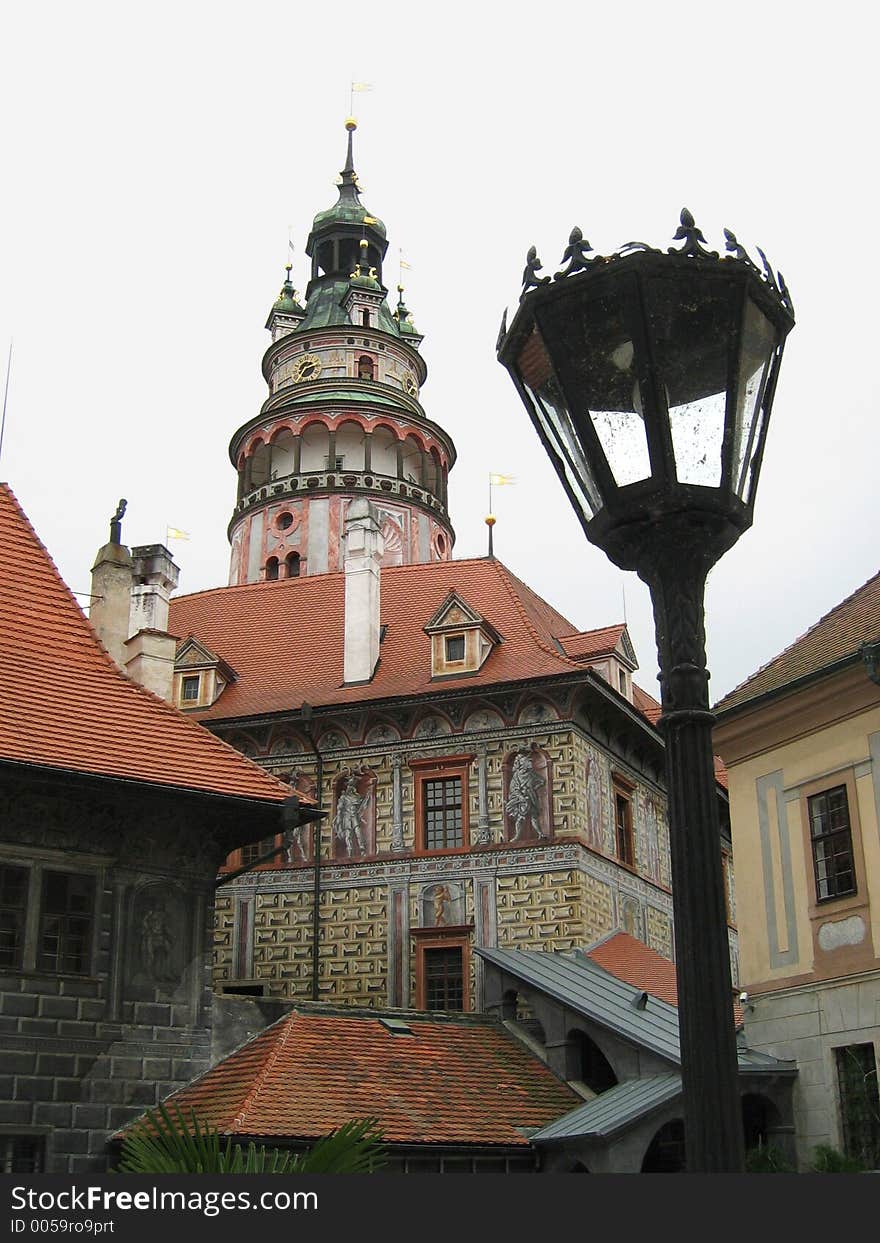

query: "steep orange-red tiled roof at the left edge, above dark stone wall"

left=0, top=484, right=291, bottom=803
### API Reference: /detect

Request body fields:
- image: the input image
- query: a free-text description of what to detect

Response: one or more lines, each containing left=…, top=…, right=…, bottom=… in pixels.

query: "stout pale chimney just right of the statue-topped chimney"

left=123, top=544, right=180, bottom=702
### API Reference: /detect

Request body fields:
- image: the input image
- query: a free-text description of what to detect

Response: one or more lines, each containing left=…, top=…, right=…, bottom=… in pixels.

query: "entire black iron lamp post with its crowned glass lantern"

left=497, top=209, right=794, bottom=1172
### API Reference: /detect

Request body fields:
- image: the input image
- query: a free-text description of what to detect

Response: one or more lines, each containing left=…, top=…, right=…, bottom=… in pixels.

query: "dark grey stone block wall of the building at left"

left=0, top=766, right=278, bottom=1173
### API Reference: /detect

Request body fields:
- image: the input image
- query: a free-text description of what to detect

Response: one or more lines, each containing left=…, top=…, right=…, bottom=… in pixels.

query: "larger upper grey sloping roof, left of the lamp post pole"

left=476, top=948, right=681, bottom=1065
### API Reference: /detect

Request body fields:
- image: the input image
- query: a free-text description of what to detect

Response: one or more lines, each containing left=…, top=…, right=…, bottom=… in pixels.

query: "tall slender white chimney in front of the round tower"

left=343, top=497, right=384, bottom=684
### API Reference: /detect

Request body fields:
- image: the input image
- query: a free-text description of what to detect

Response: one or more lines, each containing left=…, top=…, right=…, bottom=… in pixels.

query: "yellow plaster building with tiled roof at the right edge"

left=715, top=576, right=880, bottom=1167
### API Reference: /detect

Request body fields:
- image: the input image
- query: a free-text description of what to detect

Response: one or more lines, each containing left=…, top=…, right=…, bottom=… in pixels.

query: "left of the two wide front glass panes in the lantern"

left=562, top=288, right=651, bottom=487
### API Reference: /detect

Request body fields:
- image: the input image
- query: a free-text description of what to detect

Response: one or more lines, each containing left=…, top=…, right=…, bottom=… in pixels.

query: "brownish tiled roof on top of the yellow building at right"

left=715, top=574, right=880, bottom=712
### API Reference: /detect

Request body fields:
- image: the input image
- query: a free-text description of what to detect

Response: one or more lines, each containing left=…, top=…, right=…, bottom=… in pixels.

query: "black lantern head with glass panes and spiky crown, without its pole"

left=497, top=208, right=794, bottom=571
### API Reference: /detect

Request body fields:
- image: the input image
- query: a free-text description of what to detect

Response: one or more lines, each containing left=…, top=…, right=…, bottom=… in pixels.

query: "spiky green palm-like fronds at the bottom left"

left=116, top=1105, right=385, bottom=1175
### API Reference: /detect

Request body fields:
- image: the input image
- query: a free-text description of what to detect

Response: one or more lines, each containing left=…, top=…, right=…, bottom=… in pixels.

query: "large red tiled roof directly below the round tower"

left=169, top=557, right=591, bottom=720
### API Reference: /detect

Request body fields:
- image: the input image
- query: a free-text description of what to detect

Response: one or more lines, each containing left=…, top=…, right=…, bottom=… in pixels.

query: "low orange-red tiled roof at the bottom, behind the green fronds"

left=147, top=1011, right=580, bottom=1147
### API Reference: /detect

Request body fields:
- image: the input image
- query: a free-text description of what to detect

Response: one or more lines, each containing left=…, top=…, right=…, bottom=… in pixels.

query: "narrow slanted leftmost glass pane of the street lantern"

left=517, top=332, right=602, bottom=521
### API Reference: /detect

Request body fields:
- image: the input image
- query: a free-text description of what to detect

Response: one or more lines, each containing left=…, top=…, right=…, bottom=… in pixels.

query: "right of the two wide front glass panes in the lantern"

left=645, top=272, right=737, bottom=487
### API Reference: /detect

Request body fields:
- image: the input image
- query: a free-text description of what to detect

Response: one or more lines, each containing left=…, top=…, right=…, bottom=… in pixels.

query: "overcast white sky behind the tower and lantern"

left=0, top=0, right=880, bottom=699
